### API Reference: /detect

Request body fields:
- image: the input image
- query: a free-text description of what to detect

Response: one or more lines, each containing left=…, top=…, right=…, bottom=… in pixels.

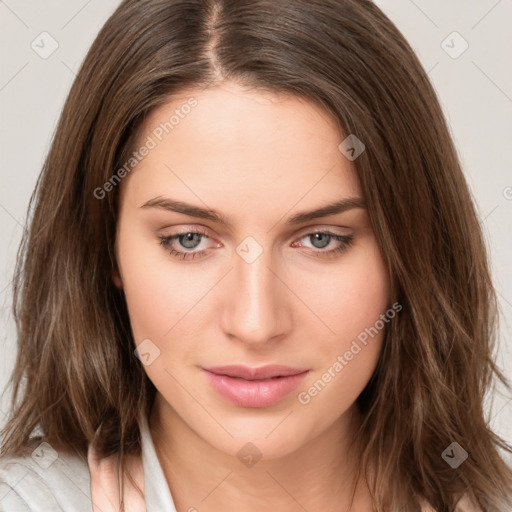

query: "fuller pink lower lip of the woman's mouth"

left=204, top=370, right=309, bottom=407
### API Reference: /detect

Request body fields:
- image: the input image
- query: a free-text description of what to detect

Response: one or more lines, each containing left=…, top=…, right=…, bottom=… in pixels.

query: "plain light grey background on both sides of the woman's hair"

left=0, top=0, right=512, bottom=460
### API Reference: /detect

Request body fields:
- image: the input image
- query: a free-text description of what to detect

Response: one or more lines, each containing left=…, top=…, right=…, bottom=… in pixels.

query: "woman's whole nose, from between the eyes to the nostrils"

left=222, top=241, right=291, bottom=346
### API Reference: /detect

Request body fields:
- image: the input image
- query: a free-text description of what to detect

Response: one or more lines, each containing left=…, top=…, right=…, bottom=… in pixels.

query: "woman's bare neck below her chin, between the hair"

left=149, top=395, right=372, bottom=512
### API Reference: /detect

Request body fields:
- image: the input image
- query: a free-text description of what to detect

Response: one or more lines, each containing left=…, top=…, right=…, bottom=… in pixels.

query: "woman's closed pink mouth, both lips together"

left=203, top=365, right=310, bottom=407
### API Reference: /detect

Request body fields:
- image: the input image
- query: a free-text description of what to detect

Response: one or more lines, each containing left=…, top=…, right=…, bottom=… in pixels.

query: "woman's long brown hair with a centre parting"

left=2, top=0, right=512, bottom=512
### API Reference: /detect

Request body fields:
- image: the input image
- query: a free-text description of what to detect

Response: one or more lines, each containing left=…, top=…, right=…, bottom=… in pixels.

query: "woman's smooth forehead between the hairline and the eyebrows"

left=123, top=83, right=360, bottom=216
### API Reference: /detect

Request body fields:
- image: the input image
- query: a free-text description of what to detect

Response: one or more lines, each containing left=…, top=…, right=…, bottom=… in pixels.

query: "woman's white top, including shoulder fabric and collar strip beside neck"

left=0, top=418, right=176, bottom=512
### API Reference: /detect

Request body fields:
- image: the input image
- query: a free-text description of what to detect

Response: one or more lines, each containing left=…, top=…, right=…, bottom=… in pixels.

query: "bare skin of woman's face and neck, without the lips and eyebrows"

left=114, top=83, right=390, bottom=512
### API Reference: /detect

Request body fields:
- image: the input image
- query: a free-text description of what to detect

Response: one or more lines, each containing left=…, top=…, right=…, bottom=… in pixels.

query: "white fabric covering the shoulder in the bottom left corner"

left=0, top=440, right=92, bottom=512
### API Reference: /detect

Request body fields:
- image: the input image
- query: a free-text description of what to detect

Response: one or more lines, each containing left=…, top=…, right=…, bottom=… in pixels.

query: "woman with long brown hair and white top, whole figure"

left=0, top=0, right=512, bottom=512
